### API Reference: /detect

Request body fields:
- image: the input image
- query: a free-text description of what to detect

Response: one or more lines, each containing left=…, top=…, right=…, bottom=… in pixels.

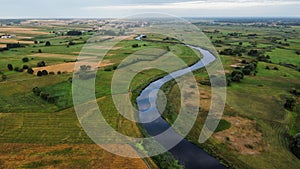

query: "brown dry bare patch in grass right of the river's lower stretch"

left=213, top=117, right=263, bottom=154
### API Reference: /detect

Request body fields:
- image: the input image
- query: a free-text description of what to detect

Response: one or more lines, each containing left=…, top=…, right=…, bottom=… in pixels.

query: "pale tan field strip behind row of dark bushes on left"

left=33, top=60, right=113, bottom=74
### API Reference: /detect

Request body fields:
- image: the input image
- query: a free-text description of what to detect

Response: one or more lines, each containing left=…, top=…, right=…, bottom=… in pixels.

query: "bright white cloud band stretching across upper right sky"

left=83, top=0, right=300, bottom=11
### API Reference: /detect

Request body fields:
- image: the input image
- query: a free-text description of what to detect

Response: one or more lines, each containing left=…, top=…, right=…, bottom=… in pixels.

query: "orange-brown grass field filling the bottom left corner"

left=0, top=143, right=148, bottom=169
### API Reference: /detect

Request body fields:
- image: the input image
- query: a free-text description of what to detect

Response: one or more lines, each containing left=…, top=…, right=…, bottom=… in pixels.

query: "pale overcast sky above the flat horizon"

left=0, top=0, right=300, bottom=18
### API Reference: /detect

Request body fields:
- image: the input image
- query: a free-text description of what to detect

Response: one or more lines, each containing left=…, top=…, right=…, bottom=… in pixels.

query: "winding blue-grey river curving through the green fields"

left=137, top=46, right=226, bottom=169
